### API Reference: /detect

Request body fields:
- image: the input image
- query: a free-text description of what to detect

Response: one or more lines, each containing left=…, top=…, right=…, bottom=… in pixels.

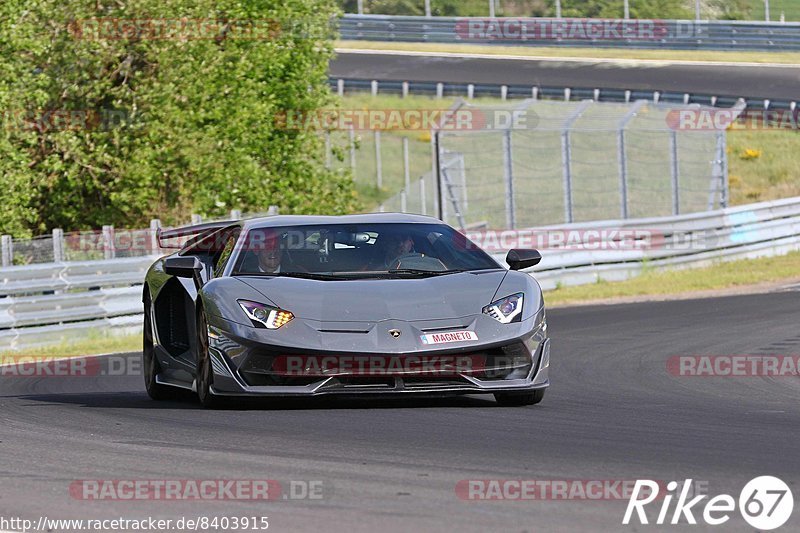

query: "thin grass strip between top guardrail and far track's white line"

left=336, top=40, right=800, bottom=65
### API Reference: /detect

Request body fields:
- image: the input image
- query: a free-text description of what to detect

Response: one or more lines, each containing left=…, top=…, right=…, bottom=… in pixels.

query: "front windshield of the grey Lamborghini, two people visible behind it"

left=234, top=224, right=501, bottom=279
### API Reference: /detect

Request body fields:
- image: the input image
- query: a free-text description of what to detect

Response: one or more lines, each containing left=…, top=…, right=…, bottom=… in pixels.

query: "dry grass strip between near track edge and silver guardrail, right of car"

left=545, top=248, right=800, bottom=305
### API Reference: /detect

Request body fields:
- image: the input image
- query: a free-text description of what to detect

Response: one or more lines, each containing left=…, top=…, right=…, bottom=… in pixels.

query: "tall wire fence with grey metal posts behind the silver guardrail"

left=378, top=100, right=744, bottom=229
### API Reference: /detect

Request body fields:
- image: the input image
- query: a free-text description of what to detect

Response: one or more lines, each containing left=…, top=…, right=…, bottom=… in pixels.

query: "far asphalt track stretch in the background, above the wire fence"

left=329, top=50, right=800, bottom=101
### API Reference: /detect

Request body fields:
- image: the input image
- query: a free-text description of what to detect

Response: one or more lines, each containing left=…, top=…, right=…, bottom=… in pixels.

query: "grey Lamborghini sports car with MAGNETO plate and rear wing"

left=143, top=213, right=550, bottom=407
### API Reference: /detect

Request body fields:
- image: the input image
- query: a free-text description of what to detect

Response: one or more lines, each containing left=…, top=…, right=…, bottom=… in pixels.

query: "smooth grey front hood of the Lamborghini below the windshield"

left=239, top=270, right=507, bottom=322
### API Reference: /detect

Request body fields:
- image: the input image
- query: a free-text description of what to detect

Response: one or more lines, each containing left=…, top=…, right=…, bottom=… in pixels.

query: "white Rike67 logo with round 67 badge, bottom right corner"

left=622, top=476, right=794, bottom=531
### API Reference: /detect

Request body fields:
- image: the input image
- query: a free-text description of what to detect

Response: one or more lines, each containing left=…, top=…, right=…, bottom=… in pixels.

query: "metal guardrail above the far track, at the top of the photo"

left=339, top=15, right=800, bottom=51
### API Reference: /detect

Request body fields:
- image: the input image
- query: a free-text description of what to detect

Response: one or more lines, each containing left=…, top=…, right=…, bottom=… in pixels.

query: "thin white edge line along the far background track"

left=335, top=48, right=800, bottom=68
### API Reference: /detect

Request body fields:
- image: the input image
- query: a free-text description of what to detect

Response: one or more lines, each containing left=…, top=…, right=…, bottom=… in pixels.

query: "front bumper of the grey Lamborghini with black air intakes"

left=209, top=311, right=550, bottom=397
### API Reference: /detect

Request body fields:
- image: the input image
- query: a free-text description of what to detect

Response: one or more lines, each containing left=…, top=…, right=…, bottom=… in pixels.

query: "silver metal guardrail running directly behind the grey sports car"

left=0, top=197, right=800, bottom=351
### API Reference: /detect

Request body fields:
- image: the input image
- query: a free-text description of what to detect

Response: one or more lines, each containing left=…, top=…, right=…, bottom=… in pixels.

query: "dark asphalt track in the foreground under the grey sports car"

left=0, top=292, right=800, bottom=532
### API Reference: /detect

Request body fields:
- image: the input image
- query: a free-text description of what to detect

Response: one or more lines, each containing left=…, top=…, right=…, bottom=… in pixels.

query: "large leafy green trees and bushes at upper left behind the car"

left=0, top=0, right=358, bottom=234
